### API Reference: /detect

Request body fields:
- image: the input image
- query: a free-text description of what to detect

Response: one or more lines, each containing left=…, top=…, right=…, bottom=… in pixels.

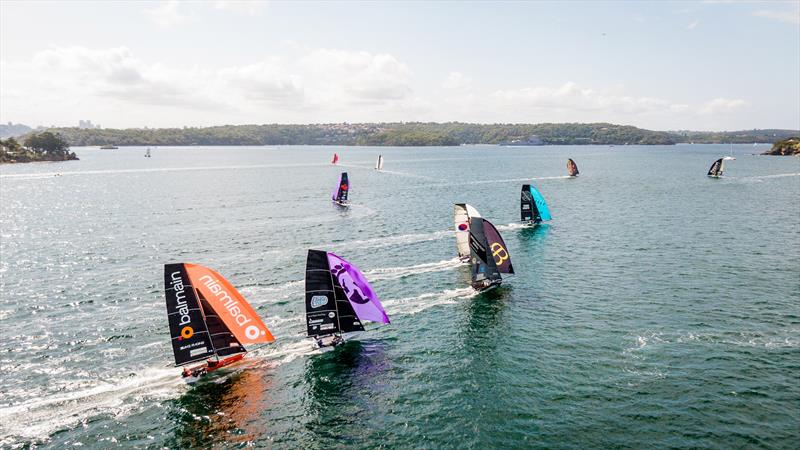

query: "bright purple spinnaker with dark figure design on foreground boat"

left=328, top=252, right=389, bottom=323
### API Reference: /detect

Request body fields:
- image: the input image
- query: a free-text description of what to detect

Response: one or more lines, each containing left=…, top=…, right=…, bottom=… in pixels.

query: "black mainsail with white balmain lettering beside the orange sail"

left=164, top=264, right=214, bottom=366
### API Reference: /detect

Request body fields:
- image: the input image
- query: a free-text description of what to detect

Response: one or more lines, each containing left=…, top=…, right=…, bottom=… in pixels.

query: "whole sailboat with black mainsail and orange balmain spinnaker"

left=164, top=263, right=275, bottom=383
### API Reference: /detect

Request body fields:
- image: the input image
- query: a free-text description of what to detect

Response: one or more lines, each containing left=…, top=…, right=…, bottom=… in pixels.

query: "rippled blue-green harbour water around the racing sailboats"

left=0, top=146, right=800, bottom=448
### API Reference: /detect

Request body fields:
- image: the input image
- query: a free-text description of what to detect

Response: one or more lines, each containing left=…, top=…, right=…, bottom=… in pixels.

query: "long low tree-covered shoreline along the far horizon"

left=6, top=122, right=800, bottom=147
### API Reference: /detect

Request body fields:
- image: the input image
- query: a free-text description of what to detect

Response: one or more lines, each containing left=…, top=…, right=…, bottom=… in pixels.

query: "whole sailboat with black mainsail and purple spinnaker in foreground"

left=305, top=250, right=389, bottom=351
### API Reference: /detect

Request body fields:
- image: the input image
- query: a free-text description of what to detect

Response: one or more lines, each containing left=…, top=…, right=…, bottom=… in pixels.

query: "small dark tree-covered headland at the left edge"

left=0, top=131, right=78, bottom=164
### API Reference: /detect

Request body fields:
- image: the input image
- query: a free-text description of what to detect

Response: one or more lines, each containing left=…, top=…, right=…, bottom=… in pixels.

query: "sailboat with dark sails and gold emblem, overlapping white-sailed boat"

left=469, top=217, right=514, bottom=291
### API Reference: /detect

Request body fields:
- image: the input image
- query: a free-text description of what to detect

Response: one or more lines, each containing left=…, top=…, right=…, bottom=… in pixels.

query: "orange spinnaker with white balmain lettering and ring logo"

left=185, top=264, right=275, bottom=345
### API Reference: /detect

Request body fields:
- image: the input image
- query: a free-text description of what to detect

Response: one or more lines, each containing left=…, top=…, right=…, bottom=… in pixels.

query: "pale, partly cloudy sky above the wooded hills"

left=0, top=0, right=800, bottom=130
